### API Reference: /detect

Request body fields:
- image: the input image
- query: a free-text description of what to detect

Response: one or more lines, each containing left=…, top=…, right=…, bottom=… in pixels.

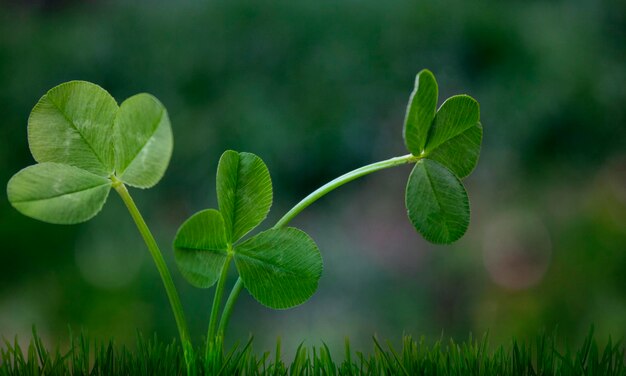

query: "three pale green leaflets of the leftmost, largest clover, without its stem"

left=7, top=81, right=172, bottom=224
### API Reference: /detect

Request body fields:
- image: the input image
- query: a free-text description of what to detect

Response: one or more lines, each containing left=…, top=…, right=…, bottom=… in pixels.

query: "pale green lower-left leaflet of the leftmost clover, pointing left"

left=7, top=162, right=111, bottom=224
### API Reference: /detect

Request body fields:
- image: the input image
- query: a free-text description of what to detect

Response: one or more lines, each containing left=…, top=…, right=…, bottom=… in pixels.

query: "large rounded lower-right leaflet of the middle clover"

left=235, top=227, right=322, bottom=309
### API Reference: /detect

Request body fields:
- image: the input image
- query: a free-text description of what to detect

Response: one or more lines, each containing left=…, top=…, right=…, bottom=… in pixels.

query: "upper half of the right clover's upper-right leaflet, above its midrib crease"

left=426, top=95, right=480, bottom=153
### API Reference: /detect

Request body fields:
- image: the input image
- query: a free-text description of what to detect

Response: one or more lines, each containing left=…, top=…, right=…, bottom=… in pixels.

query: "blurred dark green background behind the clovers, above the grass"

left=0, top=0, right=626, bottom=353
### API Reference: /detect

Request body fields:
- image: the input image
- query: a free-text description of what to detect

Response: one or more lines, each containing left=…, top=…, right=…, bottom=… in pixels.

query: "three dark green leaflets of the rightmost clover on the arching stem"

left=403, top=70, right=482, bottom=244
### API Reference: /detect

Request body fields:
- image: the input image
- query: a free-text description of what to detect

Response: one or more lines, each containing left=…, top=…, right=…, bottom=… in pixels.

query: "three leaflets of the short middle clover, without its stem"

left=174, top=150, right=322, bottom=309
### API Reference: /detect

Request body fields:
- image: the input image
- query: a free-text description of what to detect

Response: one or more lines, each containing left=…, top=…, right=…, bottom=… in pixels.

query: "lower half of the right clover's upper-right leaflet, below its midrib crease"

left=428, top=122, right=483, bottom=179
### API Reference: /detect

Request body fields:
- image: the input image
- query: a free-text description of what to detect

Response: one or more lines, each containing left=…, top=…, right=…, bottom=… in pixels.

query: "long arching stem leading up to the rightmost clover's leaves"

left=219, top=154, right=422, bottom=338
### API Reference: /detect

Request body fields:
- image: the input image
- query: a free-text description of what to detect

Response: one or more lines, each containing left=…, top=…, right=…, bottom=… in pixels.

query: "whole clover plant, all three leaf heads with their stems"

left=7, top=70, right=482, bottom=370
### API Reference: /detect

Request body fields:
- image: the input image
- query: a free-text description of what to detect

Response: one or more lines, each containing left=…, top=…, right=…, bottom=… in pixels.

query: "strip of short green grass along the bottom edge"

left=0, top=331, right=626, bottom=376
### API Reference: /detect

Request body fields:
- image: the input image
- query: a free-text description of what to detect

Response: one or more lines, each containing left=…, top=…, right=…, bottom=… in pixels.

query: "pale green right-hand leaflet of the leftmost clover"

left=115, top=93, right=173, bottom=188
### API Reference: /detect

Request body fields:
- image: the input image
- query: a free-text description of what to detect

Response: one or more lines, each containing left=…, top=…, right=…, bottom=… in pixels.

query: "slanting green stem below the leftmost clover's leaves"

left=110, top=176, right=191, bottom=361
